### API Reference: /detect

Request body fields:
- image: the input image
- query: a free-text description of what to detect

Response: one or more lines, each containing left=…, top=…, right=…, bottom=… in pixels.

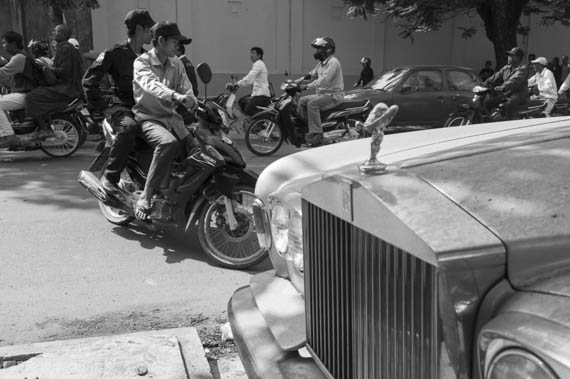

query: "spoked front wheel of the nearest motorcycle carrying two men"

left=198, top=186, right=268, bottom=269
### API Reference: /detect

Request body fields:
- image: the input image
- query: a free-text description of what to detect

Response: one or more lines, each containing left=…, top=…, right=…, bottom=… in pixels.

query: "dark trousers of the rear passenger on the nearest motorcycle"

left=105, top=107, right=140, bottom=184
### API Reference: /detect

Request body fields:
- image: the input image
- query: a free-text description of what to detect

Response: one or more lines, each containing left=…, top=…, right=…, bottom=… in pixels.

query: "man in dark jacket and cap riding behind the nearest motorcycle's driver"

left=82, top=9, right=155, bottom=192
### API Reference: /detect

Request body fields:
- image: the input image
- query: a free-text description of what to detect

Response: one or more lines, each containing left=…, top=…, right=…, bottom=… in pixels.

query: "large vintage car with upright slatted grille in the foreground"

left=228, top=113, right=570, bottom=379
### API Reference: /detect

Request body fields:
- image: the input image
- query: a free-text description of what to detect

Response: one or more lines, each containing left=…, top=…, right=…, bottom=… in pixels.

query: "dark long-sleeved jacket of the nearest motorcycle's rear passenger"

left=82, top=42, right=145, bottom=111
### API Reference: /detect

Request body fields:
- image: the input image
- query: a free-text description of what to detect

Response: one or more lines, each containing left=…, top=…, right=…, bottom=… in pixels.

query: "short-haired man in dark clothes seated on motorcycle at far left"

left=22, top=24, right=83, bottom=138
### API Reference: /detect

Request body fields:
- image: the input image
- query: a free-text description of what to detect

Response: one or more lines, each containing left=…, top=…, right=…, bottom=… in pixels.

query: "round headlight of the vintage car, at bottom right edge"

left=486, top=349, right=557, bottom=379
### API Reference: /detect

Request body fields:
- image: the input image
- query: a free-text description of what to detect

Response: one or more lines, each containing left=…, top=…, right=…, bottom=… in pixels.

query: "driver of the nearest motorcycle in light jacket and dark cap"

left=133, top=22, right=197, bottom=220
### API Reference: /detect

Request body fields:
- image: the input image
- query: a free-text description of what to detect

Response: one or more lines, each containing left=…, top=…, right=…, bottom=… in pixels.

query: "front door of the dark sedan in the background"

left=393, top=69, right=446, bottom=126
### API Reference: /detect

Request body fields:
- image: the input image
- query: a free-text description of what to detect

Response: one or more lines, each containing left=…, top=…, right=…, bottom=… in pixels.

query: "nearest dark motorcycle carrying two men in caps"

left=79, top=66, right=267, bottom=269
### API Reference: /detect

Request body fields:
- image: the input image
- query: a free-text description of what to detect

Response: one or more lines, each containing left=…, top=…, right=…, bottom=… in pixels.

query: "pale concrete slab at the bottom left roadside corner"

left=0, top=328, right=212, bottom=379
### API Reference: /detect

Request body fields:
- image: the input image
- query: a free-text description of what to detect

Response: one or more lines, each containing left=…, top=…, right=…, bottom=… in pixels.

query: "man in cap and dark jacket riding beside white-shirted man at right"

left=483, top=47, right=529, bottom=119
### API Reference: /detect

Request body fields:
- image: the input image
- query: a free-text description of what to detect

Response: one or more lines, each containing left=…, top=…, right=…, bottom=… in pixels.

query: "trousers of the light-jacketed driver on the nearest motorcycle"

left=141, top=120, right=179, bottom=194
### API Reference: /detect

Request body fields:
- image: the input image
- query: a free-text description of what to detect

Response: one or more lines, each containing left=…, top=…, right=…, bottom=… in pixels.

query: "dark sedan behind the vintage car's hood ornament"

left=345, top=65, right=479, bottom=127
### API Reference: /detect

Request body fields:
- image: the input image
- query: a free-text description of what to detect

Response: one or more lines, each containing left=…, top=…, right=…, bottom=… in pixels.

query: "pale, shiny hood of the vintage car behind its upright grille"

left=256, top=118, right=570, bottom=295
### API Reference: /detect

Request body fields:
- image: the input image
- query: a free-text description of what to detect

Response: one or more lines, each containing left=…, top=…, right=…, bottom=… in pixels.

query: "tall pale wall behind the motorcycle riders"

left=93, top=0, right=570, bottom=92
